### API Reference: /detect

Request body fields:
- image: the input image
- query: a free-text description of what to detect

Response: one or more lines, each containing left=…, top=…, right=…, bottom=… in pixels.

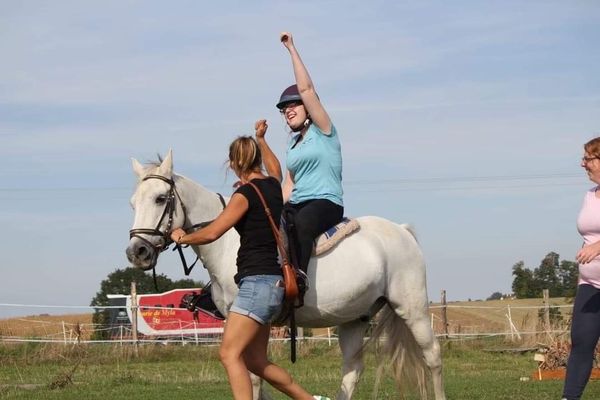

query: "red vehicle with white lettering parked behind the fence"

left=108, top=288, right=223, bottom=337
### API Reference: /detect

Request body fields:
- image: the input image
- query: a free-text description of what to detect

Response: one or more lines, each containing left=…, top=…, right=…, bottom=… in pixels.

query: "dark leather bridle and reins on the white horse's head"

left=129, top=174, right=225, bottom=278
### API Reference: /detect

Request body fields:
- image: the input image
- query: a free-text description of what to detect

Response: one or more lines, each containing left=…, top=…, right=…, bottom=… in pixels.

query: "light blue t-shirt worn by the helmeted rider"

left=286, top=124, right=344, bottom=206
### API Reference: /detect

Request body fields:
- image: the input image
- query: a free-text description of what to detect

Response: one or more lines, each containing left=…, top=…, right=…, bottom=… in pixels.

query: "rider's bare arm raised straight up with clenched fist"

left=279, top=32, right=331, bottom=135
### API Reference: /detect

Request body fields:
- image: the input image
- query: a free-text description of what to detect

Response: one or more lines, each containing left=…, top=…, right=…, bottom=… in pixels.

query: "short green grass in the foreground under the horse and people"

left=0, top=341, right=600, bottom=400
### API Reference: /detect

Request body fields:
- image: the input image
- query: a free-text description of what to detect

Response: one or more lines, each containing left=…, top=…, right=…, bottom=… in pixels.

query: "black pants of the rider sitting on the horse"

left=284, top=199, right=344, bottom=271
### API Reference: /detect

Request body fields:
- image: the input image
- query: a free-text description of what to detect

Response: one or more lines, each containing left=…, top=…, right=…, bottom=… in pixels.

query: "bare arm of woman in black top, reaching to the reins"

left=171, top=193, right=248, bottom=244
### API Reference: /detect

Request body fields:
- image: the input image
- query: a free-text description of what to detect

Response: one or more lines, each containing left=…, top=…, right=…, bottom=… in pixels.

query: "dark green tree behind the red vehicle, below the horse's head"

left=90, top=267, right=204, bottom=339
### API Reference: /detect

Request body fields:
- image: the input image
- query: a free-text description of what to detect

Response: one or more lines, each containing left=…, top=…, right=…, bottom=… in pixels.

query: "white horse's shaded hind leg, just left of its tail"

left=337, top=320, right=369, bottom=400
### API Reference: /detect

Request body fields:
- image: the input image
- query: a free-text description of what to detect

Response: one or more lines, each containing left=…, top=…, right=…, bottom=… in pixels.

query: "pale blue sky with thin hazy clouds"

left=0, top=0, right=600, bottom=318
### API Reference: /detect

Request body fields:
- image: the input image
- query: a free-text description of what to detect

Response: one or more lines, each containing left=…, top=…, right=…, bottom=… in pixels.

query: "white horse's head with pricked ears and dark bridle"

left=125, top=150, right=185, bottom=270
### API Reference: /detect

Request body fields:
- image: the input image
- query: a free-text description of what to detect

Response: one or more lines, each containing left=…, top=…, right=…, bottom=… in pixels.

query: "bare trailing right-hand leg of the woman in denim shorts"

left=243, top=325, right=313, bottom=400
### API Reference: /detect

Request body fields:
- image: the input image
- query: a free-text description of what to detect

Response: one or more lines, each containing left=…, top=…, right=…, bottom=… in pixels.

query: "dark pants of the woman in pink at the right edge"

left=563, top=285, right=600, bottom=400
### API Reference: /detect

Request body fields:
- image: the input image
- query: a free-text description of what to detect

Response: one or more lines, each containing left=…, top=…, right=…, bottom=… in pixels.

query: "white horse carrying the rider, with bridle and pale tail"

left=126, top=151, right=446, bottom=400
